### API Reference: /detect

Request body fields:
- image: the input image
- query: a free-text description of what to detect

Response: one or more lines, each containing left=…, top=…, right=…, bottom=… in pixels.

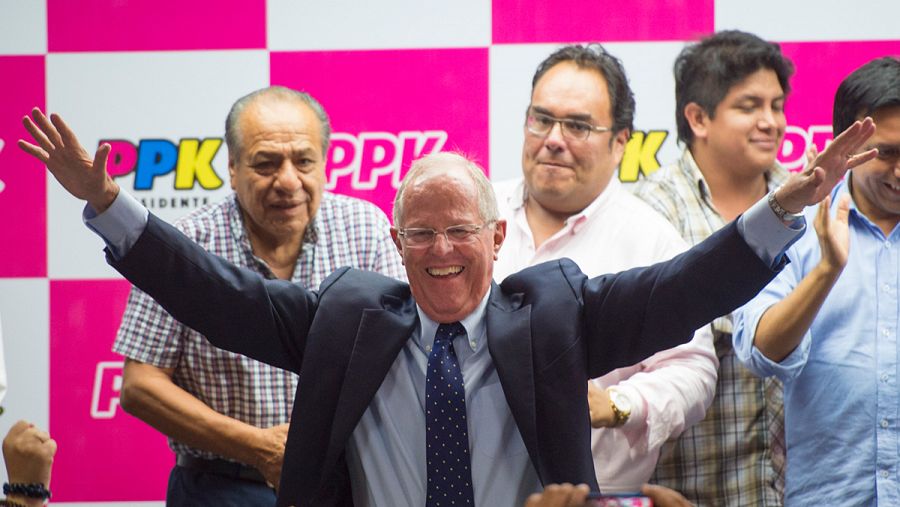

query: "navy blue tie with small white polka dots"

left=425, top=322, right=475, bottom=507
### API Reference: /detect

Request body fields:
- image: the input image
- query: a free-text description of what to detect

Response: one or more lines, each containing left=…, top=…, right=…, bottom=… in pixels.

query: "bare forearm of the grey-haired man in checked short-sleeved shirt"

left=122, top=361, right=280, bottom=466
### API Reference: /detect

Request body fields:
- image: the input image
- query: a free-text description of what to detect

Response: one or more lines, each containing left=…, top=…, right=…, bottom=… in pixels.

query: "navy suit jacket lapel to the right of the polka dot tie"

left=486, top=284, right=540, bottom=470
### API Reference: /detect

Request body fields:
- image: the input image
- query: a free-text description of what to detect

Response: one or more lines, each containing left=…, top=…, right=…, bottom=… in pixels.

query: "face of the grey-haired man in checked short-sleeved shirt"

left=228, top=97, right=325, bottom=247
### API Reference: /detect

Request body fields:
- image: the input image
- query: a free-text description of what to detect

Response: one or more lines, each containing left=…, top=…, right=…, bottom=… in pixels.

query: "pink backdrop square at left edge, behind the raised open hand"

left=0, top=56, right=47, bottom=278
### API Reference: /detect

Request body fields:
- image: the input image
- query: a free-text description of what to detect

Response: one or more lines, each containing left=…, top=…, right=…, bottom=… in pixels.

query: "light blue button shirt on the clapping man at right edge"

left=734, top=181, right=900, bottom=506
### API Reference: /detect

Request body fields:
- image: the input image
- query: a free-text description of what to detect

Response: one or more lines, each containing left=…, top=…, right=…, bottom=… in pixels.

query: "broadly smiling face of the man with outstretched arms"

left=391, top=163, right=506, bottom=323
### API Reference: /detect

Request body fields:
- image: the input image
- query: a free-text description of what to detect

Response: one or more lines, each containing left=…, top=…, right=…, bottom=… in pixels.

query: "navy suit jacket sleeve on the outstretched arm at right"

left=501, top=223, right=780, bottom=378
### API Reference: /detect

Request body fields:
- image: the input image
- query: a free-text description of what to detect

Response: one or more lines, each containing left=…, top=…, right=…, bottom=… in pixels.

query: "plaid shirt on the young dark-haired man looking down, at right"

left=633, top=150, right=788, bottom=507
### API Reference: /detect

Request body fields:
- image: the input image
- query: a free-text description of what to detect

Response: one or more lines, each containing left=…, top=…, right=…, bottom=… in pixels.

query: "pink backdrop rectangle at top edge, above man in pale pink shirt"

left=492, top=0, right=714, bottom=44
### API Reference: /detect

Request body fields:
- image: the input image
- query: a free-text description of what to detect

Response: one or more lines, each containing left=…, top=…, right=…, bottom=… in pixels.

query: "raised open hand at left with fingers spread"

left=18, top=108, right=119, bottom=212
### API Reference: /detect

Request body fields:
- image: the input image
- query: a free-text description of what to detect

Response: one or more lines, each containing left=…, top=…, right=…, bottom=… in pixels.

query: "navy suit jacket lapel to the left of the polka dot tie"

left=324, top=295, right=416, bottom=476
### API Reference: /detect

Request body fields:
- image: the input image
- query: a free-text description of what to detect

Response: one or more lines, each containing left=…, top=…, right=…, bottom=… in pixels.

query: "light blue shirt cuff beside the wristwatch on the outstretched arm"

left=737, top=193, right=806, bottom=268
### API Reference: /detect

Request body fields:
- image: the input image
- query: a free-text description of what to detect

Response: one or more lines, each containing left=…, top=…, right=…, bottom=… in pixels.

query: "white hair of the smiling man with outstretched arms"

left=394, top=151, right=500, bottom=226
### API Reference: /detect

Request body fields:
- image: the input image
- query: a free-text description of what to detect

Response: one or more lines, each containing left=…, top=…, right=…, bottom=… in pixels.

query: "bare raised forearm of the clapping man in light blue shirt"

left=753, top=262, right=841, bottom=362
